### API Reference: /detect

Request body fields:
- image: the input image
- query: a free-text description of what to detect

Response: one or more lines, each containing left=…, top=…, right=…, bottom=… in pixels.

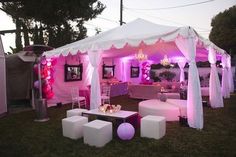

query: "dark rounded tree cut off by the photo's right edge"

left=209, top=5, right=236, bottom=55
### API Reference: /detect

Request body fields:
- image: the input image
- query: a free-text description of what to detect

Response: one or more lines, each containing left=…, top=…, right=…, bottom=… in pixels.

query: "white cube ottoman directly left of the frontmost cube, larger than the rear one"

left=62, top=116, right=88, bottom=139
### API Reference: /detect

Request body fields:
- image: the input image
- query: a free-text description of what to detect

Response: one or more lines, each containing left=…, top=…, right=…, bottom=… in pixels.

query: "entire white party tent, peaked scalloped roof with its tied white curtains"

left=44, top=19, right=229, bottom=129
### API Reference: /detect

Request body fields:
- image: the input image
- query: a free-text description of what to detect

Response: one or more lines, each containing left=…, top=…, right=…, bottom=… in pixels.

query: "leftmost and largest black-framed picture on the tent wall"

left=64, top=64, right=83, bottom=82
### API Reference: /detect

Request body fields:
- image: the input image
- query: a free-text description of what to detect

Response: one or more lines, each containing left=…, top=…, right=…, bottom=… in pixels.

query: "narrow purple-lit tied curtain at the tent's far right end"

left=221, top=54, right=230, bottom=98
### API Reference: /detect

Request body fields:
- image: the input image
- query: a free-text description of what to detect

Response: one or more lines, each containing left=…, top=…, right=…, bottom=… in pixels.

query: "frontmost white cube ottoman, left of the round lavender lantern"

left=83, top=120, right=112, bottom=147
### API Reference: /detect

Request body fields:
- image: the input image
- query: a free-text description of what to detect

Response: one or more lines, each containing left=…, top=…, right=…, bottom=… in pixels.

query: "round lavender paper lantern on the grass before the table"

left=117, top=123, right=135, bottom=140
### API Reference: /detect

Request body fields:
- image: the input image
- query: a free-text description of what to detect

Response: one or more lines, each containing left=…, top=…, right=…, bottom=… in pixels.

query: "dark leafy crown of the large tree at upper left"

left=0, top=0, right=105, bottom=51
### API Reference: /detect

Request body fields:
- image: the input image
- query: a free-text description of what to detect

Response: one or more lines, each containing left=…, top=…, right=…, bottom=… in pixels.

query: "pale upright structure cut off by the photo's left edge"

left=0, top=36, right=7, bottom=114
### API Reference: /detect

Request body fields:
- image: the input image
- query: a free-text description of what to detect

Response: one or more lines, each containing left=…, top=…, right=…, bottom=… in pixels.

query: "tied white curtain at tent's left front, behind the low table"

left=88, top=51, right=101, bottom=109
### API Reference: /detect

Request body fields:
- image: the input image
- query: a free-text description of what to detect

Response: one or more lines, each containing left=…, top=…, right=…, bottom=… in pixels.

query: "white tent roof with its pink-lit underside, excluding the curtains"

left=44, top=19, right=228, bottom=60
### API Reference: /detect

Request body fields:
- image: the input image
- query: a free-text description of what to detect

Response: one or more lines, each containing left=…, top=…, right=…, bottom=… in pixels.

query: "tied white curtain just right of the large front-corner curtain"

left=208, top=47, right=224, bottom=108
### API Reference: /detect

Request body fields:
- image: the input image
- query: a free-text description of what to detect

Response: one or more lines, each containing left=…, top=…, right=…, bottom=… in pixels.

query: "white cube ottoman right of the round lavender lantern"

left=141, top=115, right=166, bottom=139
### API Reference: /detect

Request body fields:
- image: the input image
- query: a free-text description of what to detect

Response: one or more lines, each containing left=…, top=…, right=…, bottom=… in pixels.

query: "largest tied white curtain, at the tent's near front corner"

left=175, top=36, right=203, bottom=129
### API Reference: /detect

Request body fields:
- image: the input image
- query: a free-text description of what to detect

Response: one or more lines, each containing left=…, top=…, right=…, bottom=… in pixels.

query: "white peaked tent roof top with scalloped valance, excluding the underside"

left=44, top=19, right=227, bottom=57
